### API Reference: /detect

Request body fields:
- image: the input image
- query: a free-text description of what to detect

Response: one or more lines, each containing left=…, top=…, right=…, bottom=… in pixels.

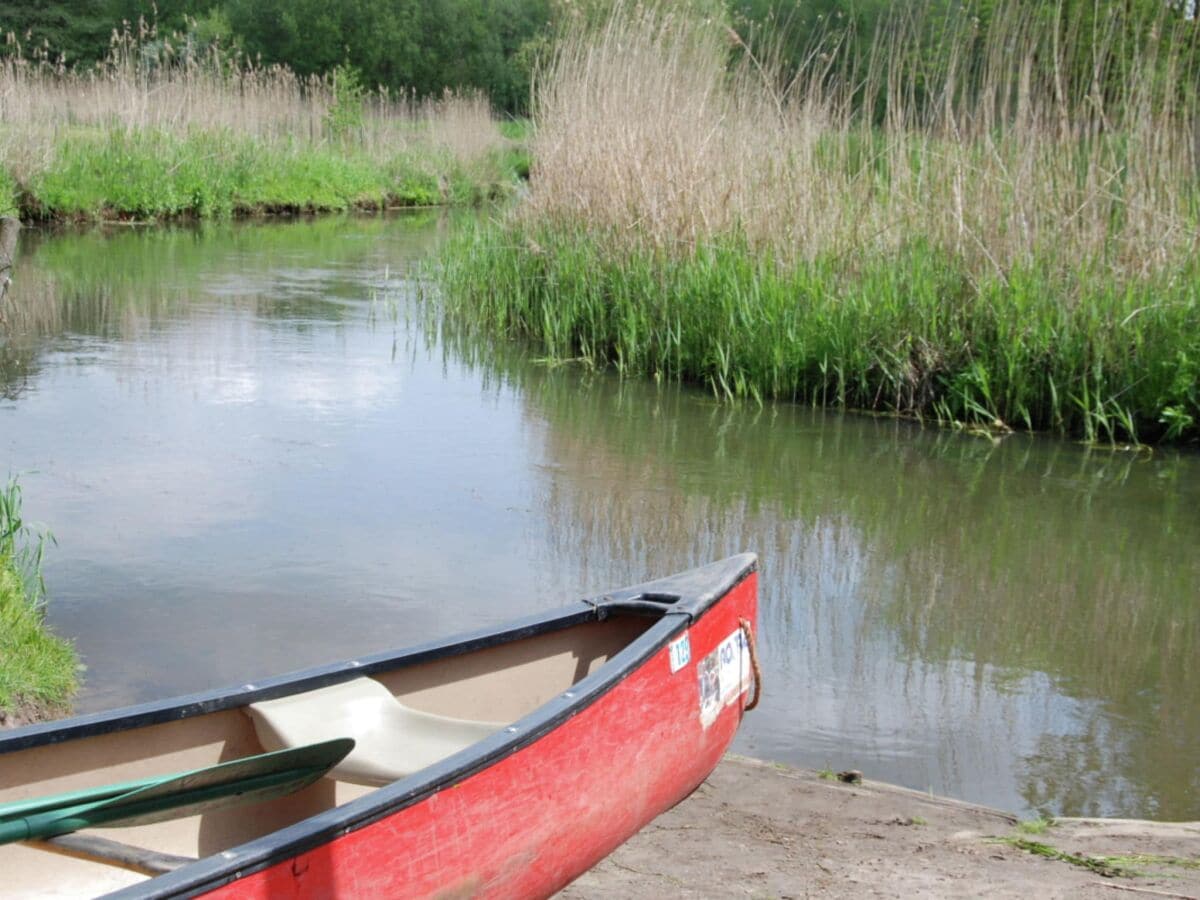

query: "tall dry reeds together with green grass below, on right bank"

left=440, top=2, right=1200, bottom=444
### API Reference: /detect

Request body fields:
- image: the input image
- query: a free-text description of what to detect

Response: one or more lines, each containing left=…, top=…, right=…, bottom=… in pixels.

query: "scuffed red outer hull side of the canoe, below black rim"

left=204, top=572, right=757, bottom=899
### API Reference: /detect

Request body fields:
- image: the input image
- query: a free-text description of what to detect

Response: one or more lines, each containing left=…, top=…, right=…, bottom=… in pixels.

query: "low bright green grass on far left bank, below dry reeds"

left=19, top=130, right=517, bottom=218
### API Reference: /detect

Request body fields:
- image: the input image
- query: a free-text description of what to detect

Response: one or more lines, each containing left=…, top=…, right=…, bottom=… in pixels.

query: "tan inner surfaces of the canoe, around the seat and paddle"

left=0, top=616, right=654, bottom=898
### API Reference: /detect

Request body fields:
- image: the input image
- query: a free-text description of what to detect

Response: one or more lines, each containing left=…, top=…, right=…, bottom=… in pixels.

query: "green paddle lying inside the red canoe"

left=0, top=738, right=354, bottom=844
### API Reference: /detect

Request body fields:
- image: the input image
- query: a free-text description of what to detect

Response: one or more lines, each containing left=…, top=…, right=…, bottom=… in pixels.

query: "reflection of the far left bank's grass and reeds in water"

left=0, top=212, right=446, bottom=400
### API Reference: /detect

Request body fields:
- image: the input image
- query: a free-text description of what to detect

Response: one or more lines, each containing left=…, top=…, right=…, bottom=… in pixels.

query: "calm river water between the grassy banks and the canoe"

left=0, top=214, right=1200, bottom=818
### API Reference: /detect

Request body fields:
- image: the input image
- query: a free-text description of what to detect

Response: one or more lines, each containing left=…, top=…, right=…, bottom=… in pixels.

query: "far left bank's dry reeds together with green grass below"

left=0, top=26, right=528, bottom=221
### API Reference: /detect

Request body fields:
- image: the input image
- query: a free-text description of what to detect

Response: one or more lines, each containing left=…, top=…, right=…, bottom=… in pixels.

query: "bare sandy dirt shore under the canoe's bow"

left=559, top=756, right=1200, bottom=900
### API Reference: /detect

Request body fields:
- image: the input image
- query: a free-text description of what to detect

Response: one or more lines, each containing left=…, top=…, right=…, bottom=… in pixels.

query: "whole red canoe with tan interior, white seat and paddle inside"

left=0, top=554, right=757, bottom=898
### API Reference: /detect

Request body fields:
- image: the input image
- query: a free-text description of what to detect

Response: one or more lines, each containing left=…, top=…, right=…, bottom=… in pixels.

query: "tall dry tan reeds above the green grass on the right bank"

left=524, top=4, right=1200, bottom=277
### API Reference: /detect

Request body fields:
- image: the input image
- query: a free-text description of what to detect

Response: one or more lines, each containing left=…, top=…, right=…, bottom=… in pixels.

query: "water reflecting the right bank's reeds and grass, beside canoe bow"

left=446, top=328, right=1200, bottom=817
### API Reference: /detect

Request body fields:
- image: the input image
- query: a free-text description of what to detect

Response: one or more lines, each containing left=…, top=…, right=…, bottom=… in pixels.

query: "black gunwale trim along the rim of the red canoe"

left=0, top=553, right=757, bottom=900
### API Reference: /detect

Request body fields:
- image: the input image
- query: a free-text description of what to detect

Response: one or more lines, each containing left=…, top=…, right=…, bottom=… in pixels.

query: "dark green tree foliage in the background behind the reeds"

left=0, top=0, right=1200, bottom=113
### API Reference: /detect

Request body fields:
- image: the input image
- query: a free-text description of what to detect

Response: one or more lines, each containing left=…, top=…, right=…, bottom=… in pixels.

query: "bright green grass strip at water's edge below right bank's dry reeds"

left=443, top=224, right=1200, bottom=443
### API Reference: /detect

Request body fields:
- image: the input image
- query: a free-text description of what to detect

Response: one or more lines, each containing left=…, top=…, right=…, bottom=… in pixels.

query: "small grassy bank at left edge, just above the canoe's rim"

left=0, top=481, right=79, bottom=725
